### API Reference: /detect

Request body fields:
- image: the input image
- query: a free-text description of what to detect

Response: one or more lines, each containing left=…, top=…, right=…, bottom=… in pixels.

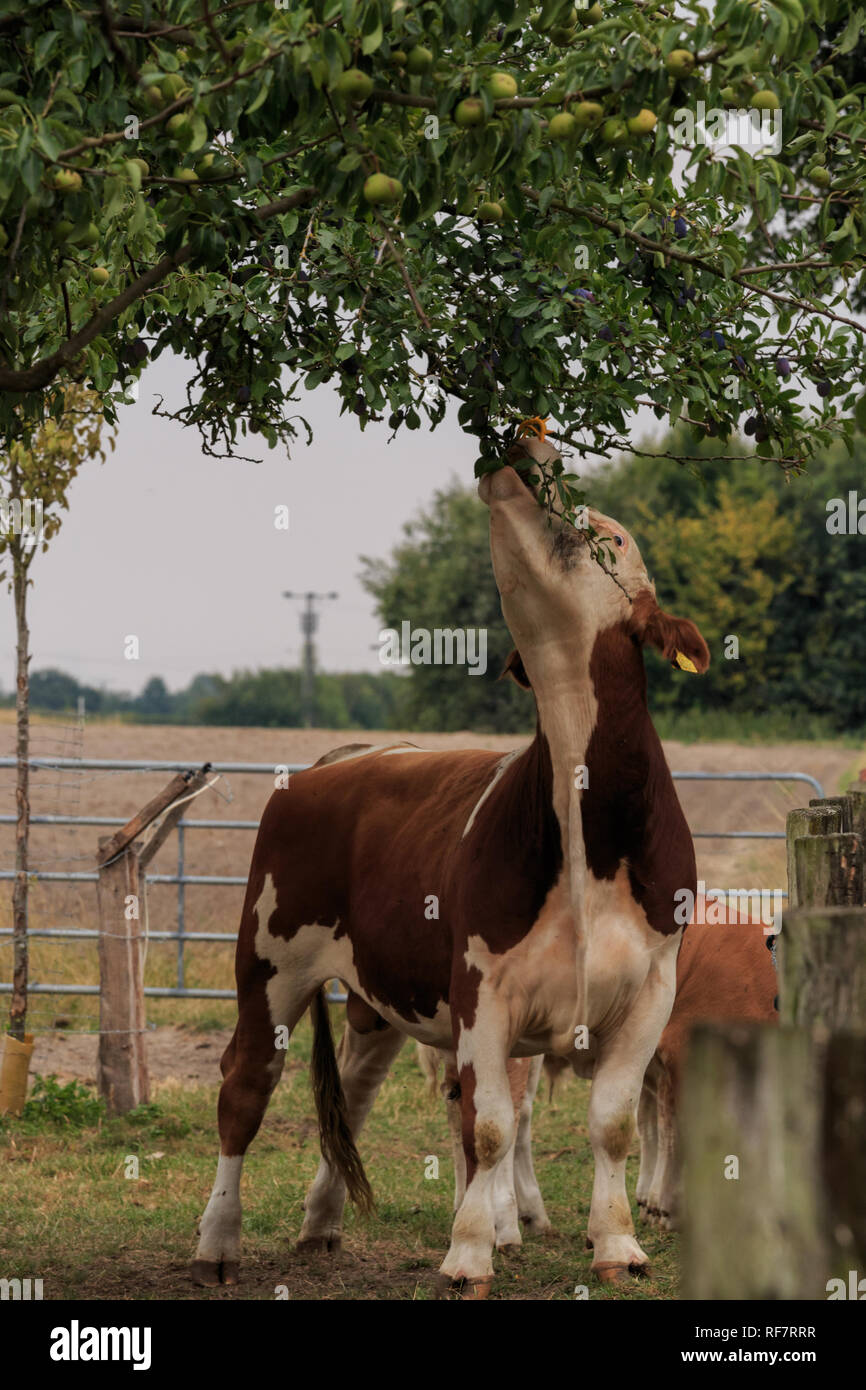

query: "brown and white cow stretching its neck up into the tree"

left=193, top=439, right=709, bottom=1294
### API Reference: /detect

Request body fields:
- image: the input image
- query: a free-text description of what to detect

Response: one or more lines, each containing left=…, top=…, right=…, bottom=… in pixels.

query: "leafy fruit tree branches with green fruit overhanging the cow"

left=0, top=0, right=866, bottom=511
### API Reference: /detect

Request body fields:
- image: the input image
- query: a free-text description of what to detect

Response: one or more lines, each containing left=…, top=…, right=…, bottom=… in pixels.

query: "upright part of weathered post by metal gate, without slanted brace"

left=96, top=835, right=150, bottom=1115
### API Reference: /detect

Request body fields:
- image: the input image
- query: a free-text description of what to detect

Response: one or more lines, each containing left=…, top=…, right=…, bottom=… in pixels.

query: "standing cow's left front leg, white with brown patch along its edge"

left=441, top=1002, right=516, bottom=1298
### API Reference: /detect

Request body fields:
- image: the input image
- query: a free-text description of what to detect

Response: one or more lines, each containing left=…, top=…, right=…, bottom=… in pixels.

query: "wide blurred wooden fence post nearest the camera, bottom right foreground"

left=681, top=1024, right=828, bottom=1300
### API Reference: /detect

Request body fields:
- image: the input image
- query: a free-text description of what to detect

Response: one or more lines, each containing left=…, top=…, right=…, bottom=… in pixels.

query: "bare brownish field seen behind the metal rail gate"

left=0, top=712, right=863, bottom=1045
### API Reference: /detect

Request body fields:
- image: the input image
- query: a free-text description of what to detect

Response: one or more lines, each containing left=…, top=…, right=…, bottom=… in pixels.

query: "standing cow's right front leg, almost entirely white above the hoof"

left=587, top=969, right=673, bottom=1283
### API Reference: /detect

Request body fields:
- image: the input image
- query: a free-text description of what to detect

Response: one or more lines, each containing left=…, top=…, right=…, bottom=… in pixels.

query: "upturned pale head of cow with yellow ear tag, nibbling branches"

left=478, top=439, right=709, bottom=682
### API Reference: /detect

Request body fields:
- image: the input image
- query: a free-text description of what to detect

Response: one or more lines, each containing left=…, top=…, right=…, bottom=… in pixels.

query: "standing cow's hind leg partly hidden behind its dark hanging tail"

left=296, top=1011, right=406, bottom=1251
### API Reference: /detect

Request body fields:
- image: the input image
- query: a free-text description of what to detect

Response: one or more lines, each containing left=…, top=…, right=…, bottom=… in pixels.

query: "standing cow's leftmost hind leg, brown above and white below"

left=192, top=959, right=315, bottom=1287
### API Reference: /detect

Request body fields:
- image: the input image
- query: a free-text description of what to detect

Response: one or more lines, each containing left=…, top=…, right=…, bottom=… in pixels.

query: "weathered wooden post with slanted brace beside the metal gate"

left=96, top=765, right=210, bottom=1115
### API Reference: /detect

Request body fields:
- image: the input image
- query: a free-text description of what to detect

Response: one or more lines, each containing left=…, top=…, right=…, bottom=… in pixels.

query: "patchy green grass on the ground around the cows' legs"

left=0, top=1022, right=678, bottom=1301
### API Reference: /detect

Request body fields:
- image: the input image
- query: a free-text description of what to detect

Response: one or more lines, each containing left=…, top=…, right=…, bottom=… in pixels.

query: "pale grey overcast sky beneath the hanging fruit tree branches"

left=0, top=354, right=622, bottom=692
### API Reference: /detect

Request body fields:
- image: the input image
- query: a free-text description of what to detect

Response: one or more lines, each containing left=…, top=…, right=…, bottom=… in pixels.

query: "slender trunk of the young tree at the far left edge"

left=10, top=537, right=31, bottom=1041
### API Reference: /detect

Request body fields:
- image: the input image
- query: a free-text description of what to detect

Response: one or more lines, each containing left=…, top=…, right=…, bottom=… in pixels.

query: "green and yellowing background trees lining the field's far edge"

left=8, top=427, right=866, bottom=738
